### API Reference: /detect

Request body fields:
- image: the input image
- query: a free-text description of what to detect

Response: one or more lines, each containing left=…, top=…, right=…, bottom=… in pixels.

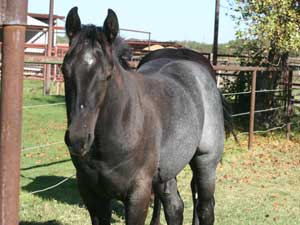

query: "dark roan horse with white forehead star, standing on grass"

left=62, top=7, right=224, bottom=225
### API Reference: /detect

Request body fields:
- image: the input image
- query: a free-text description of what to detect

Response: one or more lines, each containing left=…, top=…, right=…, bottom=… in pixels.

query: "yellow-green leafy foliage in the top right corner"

left=231, top=0, right=300, bottom=63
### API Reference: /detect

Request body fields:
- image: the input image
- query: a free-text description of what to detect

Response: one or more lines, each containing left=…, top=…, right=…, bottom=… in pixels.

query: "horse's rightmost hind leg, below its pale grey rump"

left=190, top=150, right=218, bottom=225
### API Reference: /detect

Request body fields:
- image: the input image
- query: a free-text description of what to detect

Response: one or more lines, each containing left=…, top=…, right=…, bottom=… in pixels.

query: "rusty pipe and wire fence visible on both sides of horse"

left=0, top=50, right=300, bottom=205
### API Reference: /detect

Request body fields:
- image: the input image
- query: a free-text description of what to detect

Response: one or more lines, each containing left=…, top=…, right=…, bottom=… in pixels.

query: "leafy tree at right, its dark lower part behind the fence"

left=230, top=0, right=300, bottom=126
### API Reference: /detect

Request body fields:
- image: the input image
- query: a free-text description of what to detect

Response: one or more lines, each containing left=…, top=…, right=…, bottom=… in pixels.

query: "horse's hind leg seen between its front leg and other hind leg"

left=154, top=178, right=184, bottom=225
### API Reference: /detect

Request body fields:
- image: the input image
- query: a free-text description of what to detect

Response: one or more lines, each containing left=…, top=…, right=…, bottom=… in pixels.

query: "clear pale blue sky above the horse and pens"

left=28, top=0, right=235, bottom=43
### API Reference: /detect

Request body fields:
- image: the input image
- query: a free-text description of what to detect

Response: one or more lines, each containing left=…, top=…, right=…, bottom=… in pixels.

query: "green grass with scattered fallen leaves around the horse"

left=20, top=81, right=300, bottom=225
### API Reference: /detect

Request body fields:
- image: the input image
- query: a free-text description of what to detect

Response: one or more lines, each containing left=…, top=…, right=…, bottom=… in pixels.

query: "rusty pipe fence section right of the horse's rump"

left=214, top=65, right=293, bottom=149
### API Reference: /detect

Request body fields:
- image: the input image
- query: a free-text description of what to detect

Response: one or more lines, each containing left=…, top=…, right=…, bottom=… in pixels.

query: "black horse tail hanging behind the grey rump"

left=220, top=92, right=240, bottom=143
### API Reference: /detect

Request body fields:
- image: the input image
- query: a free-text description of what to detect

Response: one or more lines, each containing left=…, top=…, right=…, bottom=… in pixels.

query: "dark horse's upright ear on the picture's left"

left=66, top=7, right=81, bottom=40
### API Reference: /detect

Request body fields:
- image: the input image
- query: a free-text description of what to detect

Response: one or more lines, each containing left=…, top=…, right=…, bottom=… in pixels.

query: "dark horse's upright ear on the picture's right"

left=103, top=9, right=119, bottom=44
